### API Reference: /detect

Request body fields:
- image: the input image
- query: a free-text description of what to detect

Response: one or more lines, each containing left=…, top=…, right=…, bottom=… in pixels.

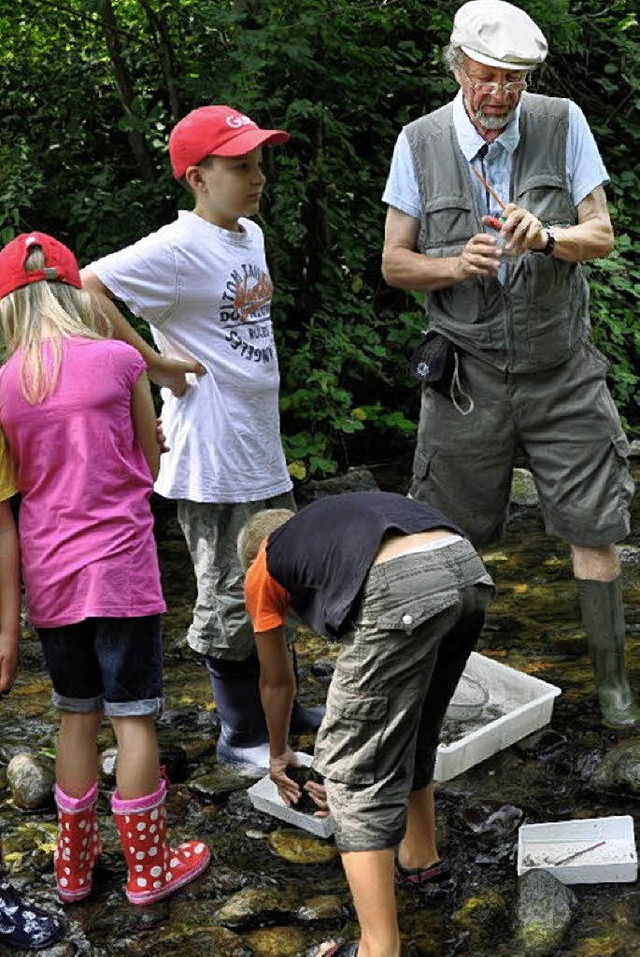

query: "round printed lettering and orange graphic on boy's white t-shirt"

left=220, top=263, right=275, bottom=362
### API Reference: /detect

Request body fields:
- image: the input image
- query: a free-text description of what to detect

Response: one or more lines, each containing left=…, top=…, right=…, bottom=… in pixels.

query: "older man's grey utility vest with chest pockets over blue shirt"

left=405, top=93, right=590, bottom=372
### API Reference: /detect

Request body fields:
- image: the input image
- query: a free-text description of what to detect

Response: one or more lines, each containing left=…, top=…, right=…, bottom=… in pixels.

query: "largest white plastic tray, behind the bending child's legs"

left=434, top=651, right=561, bottom=781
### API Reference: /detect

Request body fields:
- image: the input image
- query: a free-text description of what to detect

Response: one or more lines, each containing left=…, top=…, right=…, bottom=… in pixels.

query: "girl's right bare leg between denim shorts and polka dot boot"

left=111, top=714, right=160, bottom=801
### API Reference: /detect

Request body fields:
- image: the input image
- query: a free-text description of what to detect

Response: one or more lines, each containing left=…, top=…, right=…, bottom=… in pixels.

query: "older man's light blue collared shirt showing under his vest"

left=382, top=90, right=609, bottom=219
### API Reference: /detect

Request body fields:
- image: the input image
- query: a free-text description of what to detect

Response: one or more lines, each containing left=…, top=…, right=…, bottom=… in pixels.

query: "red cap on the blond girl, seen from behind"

left=0, top=233, right=82, bottom=298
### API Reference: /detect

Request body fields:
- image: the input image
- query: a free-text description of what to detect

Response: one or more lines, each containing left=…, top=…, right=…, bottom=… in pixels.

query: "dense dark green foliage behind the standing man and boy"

left=0, top=0, right=640, bottom=477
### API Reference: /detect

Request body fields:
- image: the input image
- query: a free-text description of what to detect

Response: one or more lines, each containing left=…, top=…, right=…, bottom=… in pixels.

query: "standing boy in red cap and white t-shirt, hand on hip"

left=83, top=105, right=321, bottom=767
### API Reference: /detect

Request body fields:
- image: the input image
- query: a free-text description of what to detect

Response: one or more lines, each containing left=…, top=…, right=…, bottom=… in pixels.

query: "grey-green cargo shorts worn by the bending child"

left=313, top=540, right=493, bottom=852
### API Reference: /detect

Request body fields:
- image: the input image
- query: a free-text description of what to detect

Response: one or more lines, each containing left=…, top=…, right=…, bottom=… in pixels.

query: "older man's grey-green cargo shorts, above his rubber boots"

left=409, top=342, right=633, bottom=548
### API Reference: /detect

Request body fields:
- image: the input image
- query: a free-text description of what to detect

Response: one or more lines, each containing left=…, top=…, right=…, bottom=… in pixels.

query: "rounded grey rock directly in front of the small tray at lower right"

left=514, top=870, right=578, bottom=957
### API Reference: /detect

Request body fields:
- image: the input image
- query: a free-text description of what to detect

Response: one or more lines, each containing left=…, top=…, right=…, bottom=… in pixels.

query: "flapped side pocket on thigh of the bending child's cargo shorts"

left=313, top=685, right=387, bottom=785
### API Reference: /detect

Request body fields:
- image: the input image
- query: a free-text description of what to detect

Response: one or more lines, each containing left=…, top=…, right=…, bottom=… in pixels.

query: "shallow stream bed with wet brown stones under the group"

left=0, top=462, right=640, bottom=957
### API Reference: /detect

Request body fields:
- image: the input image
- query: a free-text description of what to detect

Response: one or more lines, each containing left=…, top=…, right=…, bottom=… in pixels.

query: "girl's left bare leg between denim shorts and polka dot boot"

left=56, top=711, right=102, bottom=798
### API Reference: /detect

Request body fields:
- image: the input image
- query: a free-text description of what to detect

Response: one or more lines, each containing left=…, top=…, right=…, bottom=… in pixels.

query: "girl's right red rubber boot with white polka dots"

left=111, top=780, right=211, bottom=904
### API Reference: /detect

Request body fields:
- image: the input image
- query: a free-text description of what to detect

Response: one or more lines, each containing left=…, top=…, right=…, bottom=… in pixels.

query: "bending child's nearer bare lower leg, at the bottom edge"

left=342, top=850, right=400, bottom=957
